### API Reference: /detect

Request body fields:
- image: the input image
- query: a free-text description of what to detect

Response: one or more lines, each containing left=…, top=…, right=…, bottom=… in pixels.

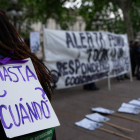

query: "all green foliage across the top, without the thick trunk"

left=0, top=0, right=140, bottom=36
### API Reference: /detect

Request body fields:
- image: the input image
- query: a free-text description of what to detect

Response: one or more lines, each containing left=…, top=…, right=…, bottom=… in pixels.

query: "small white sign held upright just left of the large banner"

left=30, top=32, right=40, bottom=53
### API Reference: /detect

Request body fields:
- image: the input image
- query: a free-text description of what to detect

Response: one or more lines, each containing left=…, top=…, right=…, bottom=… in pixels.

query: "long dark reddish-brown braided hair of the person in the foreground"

left=0, top=10, right=53, bottom=100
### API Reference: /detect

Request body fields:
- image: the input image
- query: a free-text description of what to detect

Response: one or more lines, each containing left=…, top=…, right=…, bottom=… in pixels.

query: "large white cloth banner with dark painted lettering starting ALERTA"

left=44, top=29, right=130, bottom=89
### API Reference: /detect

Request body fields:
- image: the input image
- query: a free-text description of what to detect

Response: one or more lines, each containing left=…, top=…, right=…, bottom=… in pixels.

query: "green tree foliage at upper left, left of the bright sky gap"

left=0, top=0, right=75, bottom=37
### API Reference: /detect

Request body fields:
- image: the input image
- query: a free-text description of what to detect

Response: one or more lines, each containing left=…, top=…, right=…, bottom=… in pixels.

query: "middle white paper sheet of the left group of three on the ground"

left=86, top=113, right=110, bottom=122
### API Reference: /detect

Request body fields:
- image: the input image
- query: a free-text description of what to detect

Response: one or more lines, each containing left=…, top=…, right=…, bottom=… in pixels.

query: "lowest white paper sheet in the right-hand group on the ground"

left=118, top=107, right=139, bottom=114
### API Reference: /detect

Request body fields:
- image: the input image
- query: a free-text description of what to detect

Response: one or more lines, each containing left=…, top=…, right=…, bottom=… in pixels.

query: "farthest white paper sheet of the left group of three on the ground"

left=92, top=107, right=115, bottom=114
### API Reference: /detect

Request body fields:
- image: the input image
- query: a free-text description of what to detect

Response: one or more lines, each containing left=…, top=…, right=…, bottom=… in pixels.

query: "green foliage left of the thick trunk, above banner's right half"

left=79, top=0, right=125, bottom=33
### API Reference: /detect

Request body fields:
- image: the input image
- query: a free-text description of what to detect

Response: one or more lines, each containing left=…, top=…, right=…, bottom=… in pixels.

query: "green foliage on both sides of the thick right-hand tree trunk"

left=79, top=0, right=140, bottom=35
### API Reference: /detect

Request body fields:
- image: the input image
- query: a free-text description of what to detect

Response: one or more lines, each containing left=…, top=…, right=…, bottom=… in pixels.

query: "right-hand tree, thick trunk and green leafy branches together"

left=80, top=0, right=140, bottom=40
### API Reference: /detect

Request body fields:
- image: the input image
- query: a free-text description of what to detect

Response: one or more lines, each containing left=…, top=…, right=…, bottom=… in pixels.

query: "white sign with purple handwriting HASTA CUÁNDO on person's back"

left=0, top=58, right=59, bottom=138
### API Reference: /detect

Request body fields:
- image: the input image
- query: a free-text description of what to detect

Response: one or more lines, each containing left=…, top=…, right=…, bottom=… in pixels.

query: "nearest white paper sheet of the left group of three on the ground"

left=75, top=118, right=102, bottom=130
